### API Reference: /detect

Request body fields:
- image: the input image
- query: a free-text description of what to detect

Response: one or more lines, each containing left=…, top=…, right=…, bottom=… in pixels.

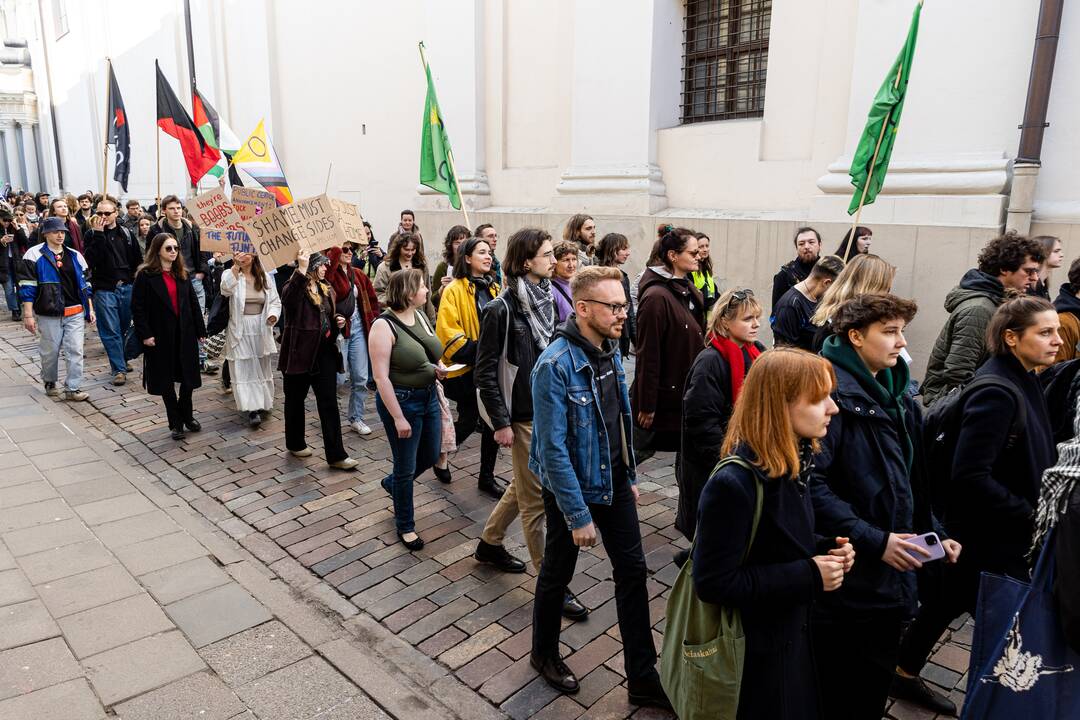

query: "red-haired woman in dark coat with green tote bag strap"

left=692, top=348, right=854, bottom=720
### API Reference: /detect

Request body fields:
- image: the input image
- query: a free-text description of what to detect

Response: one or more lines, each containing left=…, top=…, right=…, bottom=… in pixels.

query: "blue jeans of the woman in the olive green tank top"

left=375, top=383, right=443, bottom=534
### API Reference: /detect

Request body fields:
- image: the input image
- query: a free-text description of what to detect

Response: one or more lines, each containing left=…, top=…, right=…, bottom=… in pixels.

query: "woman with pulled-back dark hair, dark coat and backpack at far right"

left=897, top=296, right=1062, bottom=708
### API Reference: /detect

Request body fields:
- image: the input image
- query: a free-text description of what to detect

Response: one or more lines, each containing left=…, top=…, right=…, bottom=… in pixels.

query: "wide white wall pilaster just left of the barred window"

left=540, top=0, right=683, bottom=215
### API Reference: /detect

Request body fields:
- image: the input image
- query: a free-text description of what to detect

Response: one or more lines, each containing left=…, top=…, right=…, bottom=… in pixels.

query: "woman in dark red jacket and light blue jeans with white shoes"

left=326, top=243, right=379, bottom=435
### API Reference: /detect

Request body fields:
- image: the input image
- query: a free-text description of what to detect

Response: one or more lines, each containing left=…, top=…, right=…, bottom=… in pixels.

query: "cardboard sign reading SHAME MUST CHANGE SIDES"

left=243, top=194, right=366, bottom=268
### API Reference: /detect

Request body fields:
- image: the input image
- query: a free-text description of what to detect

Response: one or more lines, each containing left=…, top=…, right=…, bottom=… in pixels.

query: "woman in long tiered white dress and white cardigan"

left=221, top=253, right=281, bottom=427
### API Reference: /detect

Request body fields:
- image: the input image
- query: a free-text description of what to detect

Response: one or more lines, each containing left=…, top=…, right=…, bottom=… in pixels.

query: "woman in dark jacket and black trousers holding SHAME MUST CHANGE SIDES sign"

left=278, top=249, right=360, bottom=470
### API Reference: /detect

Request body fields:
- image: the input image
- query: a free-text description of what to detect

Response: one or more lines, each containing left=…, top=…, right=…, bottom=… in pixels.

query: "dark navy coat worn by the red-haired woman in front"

left=693, top=449, right=820, bottom=720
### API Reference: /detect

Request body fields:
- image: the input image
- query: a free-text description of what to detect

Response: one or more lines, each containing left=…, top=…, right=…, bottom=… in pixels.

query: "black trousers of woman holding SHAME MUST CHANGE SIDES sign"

left=282, top=342, right=349, bottom=462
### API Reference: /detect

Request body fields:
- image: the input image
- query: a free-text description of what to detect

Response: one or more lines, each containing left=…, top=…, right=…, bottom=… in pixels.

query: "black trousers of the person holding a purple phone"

left=813, top=610, right=904, bottom=720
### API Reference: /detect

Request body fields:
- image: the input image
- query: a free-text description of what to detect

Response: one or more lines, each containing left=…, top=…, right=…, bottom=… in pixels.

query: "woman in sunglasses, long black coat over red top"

left=132, top=233, right=206, bottom=440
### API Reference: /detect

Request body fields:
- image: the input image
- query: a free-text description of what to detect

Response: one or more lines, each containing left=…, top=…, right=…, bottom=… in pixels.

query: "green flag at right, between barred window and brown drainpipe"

left=848, top=0, right=922, bottom=215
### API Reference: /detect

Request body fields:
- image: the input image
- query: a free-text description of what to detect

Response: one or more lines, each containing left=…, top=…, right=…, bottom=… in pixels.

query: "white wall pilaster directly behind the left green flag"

left=417, top=0, right=491, bottom=209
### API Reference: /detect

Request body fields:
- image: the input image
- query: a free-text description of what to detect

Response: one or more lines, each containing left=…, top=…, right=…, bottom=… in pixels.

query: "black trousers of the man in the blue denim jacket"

left=532, top=478, right=657, bottom=683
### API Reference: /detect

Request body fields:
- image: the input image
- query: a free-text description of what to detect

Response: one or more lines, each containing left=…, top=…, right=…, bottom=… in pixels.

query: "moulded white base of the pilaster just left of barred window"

left=552, top=163, right=667, bottom=215
